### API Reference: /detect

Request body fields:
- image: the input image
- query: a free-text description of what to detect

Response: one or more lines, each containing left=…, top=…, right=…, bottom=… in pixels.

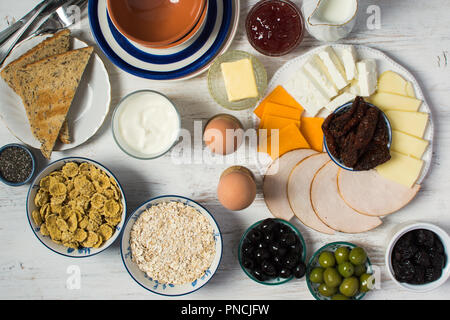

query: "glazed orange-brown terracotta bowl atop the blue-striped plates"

left=107, top=0, right=207, bottom=47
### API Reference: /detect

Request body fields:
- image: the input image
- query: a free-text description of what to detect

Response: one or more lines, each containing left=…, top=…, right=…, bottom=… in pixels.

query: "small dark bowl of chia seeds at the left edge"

left=0, top=143, right=36, bottom=187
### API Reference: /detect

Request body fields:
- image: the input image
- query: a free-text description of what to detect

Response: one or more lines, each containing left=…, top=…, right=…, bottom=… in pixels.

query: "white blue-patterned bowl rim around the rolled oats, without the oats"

left=120, top=195, right=223, bottom=296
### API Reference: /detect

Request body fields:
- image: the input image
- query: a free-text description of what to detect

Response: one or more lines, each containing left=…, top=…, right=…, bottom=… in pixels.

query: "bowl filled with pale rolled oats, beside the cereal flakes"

left=120, top=195, right=223, bottom=296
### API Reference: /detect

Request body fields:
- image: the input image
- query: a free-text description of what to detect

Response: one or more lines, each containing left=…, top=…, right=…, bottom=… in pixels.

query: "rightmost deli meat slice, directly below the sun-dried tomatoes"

left=338, top=169, right=420, bottom=216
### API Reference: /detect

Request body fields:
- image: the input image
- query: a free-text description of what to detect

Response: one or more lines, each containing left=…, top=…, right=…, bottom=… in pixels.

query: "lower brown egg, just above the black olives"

left=217, top=166, right=256, bottom=211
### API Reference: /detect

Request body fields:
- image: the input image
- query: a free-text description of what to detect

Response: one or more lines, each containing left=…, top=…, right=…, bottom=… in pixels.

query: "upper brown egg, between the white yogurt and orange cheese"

left=203, top=114, right=244, bottom=155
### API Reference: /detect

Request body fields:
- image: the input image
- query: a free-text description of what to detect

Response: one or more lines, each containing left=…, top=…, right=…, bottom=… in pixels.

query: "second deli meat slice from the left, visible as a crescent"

left=288, top=153, right=335, bottom=234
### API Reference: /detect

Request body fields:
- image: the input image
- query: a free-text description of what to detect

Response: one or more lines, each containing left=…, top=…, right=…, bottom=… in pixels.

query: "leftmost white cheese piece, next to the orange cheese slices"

left=284, top=70, right=330, bottom=117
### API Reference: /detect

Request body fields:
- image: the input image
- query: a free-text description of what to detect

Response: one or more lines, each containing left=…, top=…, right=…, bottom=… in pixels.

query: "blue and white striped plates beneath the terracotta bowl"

left=89, top=0, right=240, bottom=81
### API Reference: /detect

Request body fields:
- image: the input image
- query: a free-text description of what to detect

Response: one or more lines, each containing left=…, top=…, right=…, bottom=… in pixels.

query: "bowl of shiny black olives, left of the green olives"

left=238, top=218, right=306, bottom=285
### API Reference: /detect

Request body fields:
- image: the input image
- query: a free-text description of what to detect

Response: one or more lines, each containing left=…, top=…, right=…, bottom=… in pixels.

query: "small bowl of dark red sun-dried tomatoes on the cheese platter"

left=322, top=97, right=392, bottom=171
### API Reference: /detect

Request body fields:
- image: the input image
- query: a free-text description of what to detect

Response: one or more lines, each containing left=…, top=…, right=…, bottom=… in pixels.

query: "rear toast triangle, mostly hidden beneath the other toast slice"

left=1, top=29, right=71, bottom=144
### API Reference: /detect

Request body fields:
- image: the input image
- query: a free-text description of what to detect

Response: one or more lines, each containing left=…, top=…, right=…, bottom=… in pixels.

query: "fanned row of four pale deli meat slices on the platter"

left=263, top=149, right=420, bottom=234
